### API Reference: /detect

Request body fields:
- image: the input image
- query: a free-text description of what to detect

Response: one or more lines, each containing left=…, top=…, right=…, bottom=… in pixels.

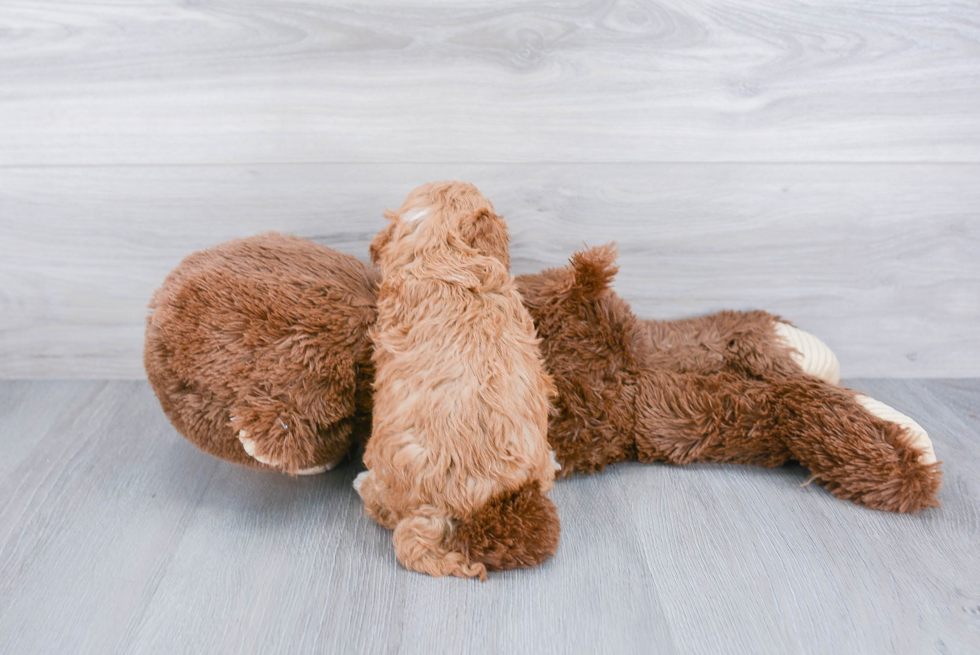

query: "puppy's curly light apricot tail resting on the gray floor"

left=394, top=515, right=487, bottom=580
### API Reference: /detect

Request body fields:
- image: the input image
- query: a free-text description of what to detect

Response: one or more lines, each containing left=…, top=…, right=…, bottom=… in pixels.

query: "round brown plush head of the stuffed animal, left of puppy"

left=143, top=233, right=379, bottom=473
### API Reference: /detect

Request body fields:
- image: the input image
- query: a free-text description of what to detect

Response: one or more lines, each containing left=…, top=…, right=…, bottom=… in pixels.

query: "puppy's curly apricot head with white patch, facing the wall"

left=370, top=182, right=510, bottom=270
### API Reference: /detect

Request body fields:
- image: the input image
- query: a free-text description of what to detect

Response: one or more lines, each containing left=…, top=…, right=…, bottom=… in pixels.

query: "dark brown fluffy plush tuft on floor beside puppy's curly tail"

left=450, top=480, right=561, bottom=571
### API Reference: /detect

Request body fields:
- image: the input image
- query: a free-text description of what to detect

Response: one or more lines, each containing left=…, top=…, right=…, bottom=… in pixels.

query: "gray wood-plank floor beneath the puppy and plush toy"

left=0, top=380, right=980, bottom=655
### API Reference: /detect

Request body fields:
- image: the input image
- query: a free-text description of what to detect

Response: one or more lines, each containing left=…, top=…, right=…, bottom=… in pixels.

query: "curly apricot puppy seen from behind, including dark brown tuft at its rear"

left=356, top=182, right=559, bottom=579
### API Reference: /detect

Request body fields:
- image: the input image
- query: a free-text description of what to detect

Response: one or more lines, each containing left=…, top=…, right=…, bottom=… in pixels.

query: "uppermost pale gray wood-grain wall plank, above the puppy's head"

left=0, top=0, right=980, bottom=166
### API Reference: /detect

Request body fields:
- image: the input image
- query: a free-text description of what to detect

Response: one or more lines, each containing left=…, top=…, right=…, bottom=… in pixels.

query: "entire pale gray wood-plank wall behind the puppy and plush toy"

left=0, top=0, right=980, bottom=378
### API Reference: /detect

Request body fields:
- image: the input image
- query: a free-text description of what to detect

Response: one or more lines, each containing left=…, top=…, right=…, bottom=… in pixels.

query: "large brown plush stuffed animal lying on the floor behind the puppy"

left=144, top=210, right=942, bottom=516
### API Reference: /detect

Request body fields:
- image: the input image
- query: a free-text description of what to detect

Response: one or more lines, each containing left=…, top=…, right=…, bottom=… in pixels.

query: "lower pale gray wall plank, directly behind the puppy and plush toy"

left=0, top=164, right=980, bottom=378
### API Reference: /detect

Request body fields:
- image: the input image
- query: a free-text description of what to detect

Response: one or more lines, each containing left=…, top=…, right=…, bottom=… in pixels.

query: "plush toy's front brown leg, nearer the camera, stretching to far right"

left=636, top=373, right=942, bottom=512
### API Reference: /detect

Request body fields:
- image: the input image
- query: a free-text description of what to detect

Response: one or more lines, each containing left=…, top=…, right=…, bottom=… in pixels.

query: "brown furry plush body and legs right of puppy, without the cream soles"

left=519, top=247, right=942, bottom=512
